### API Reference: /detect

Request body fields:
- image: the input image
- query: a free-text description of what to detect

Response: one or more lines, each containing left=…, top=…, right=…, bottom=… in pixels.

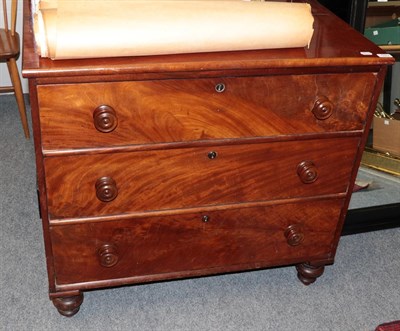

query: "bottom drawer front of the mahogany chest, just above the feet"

left=51, top=200, right=343, bottom=285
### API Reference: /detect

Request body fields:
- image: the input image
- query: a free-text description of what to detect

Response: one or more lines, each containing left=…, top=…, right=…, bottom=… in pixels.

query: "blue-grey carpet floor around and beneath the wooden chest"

left=0, top=96, right=400, bottom=331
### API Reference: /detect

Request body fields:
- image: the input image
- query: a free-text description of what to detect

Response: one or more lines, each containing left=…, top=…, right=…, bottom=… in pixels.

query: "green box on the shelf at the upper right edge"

left=364, top=19, right=400, bottom=45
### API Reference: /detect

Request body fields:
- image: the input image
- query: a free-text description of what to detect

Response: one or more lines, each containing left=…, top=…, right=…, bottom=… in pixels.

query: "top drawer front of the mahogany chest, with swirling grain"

left=38, top=73, right=376, bottom=150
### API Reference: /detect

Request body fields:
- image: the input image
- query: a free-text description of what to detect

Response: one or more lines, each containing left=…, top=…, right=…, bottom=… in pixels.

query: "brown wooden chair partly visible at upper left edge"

left=0, top=0, right=29, bottom=139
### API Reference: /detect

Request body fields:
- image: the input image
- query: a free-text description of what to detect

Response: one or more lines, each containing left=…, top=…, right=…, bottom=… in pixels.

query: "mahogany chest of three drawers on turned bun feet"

left=23, top=1, right=393, bottom=316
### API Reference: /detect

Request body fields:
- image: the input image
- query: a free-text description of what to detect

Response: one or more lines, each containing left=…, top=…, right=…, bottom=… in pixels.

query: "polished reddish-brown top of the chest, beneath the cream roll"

left=23, top=0, right=394, bottom=79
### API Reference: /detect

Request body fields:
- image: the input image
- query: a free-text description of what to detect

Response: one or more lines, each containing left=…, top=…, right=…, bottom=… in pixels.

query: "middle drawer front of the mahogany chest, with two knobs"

left=45, top=138, right=359, bottom=219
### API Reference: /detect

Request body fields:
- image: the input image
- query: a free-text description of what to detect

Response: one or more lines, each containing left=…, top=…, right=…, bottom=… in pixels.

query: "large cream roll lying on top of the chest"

left=35, top=0, right=314, bottom=59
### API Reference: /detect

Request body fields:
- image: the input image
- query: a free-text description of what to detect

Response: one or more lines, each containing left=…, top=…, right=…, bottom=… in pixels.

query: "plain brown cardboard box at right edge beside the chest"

left=372, top=117, right=400, bottom=157
